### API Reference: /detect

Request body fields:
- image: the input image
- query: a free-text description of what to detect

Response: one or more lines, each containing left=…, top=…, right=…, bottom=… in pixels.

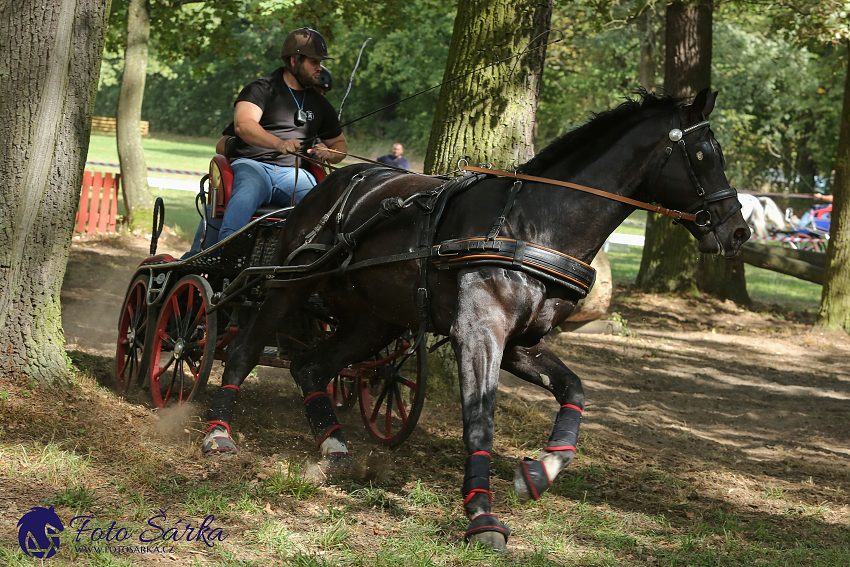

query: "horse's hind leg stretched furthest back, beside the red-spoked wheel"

left=201, top=289, right=303, bottom=459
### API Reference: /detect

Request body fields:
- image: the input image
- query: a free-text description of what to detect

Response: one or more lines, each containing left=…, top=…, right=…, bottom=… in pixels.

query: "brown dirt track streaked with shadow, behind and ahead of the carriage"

left=62, top=233, right=850, bottom=540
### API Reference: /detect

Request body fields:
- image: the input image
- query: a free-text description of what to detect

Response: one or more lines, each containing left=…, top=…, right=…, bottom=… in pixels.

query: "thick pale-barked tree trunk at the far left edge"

left=0, top=0, right=109, bottom=384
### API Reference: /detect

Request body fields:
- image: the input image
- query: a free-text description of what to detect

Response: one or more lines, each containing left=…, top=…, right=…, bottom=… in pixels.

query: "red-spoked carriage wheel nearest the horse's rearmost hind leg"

left=150, top=275, right=217, bottom=409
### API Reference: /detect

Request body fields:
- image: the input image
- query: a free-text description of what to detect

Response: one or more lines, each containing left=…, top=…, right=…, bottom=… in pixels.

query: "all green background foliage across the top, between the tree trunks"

left=95, top=0, right=850, bottom=191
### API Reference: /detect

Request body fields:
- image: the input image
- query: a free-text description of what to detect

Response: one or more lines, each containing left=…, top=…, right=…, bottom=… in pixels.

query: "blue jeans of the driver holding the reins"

left=218, top=158, right=316, bottom=241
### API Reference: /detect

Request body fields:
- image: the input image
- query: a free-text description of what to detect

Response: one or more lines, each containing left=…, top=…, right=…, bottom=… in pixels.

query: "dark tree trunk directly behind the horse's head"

left=635, top=0, right=732, bottom=299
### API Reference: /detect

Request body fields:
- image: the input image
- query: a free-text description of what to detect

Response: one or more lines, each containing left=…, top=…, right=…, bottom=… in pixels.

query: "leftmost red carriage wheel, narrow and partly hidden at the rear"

left=115, top=276, right=153, bottom=394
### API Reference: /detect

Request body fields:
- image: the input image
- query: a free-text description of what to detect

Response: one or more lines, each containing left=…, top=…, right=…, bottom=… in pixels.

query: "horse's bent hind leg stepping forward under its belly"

left=290, top=318, right=402, bottom=475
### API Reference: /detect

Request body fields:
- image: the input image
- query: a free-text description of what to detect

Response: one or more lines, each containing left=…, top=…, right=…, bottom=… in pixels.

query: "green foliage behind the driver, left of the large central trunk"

left=95, top=0, right=454, bottom=150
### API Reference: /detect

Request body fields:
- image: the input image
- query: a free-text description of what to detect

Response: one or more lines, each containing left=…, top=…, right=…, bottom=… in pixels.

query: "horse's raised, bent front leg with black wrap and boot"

left=502, top=339, right=584, bottom=502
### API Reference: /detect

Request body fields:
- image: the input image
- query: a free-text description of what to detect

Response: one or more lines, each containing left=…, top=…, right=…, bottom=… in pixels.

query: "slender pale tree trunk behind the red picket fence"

left=117, top=0, right=153, bottom=228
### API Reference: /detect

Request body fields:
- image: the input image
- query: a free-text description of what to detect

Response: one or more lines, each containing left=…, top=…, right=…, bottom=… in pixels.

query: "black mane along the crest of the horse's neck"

left=518, top=88, right=685, bottom=175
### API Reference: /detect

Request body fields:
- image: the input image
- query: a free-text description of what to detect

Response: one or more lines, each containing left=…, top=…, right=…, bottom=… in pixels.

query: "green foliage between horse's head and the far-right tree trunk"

left=712, top=12, right=847, bottom=192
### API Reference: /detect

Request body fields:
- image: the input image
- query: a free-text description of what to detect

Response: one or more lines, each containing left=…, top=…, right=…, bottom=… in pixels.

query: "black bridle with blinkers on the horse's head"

left=649, top=112, right=741, bottom=231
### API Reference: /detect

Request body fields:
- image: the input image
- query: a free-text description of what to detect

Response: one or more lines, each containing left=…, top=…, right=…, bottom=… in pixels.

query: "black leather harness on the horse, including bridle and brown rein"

left=265, top=112, right=741, bottom=353
